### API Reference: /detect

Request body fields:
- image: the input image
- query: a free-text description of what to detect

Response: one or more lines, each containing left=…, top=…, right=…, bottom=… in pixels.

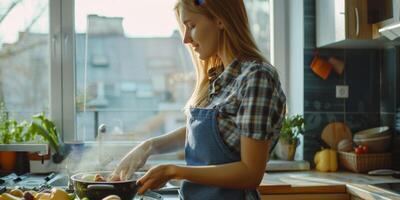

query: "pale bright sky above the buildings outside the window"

left=0, top=0, right=177, bottom=44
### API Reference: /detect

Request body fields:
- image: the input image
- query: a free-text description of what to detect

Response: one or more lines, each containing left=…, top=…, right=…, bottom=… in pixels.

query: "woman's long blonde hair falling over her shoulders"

left=175, top=0, right=267, bottom=108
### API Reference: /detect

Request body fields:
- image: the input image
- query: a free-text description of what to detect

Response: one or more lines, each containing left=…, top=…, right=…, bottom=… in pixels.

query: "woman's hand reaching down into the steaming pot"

left=110, top=143, right=150, bottom=181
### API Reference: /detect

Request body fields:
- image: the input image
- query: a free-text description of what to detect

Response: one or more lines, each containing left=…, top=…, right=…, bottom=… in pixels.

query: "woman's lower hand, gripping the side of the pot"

left=137, top=165, right=176, bottom=194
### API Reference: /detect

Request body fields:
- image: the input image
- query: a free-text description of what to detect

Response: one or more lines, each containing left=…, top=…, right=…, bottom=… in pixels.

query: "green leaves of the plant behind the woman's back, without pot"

left=279, top=115, right=304, bottom=144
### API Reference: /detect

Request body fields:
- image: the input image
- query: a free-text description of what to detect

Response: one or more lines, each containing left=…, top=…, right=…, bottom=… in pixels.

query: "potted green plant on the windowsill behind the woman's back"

left=275, top=115, right=304, bottom=160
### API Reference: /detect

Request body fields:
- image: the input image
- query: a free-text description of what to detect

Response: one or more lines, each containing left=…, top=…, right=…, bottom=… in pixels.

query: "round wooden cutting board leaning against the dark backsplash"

left=321, top=122, right=353, bottom=150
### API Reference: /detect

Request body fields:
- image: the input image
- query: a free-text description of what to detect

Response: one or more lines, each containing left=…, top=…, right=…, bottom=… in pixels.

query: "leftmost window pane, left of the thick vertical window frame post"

left=0, top=0, right=50, bottom=120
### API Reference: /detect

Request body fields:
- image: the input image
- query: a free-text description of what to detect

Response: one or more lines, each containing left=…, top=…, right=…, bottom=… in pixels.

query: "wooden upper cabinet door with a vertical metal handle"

left=346, top=0, right=372, bottom=39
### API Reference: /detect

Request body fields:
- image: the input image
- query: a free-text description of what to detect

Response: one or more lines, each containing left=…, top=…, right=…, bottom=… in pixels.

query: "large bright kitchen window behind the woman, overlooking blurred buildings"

left=0, top=0, right=270, bottom=147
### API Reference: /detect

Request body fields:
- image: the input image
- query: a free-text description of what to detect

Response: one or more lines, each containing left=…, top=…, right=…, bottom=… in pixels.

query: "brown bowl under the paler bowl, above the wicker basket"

left=353, top=134, right=392, bottom=153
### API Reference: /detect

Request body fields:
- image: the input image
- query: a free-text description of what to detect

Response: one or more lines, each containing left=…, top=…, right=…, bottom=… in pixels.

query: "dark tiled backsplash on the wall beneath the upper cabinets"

left=304, top=0, right=400, bottom=168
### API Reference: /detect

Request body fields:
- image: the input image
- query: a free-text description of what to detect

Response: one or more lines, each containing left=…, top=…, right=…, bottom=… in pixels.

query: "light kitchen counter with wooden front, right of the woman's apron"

left=258, top=171, right=400, bottom=200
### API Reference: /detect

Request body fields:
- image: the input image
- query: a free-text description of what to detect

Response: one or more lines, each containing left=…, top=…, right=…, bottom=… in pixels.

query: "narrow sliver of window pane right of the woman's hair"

left=244, top=0, right=271, bottom=60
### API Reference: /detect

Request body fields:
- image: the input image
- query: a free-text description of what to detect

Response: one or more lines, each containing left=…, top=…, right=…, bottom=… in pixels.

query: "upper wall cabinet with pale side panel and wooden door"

left=316, top=0, right=374, bottom=48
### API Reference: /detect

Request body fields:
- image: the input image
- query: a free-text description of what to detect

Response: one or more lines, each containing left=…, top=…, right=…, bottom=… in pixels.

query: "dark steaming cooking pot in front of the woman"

left=71, top=171, right=139, bottom=200
